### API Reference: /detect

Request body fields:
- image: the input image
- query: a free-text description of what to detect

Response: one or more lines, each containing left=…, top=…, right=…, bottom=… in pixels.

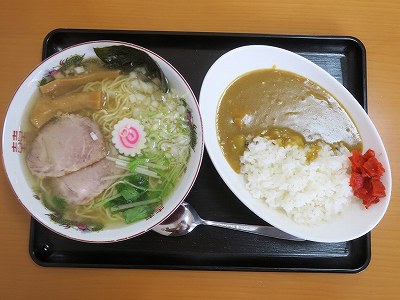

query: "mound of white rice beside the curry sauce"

left=240, top=137, right=354, bottom=225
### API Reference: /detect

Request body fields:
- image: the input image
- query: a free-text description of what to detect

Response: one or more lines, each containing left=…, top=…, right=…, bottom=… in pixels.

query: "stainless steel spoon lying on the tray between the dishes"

left=153, top=202, right=304, bottom=241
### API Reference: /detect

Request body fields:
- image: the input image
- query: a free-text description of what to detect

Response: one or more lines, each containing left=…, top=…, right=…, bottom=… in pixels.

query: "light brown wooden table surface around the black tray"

left=0, top=0, right=400, bottom=299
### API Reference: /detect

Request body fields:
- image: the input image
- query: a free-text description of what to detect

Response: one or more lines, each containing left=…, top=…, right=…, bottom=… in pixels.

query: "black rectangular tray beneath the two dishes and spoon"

left=29, top=29, right=371, bottom=273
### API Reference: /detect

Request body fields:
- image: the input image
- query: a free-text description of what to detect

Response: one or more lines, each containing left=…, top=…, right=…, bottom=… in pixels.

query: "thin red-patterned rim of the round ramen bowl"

left=1, top=39, right=205, bottom=244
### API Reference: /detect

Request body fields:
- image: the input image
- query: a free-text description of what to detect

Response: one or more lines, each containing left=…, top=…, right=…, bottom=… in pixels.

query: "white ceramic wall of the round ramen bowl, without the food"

left=2, top=41, right=204, bottom=242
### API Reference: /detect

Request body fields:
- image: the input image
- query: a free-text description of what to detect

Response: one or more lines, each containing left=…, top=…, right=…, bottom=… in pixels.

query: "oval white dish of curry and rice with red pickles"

left=199, top=45, right=392, bottom=242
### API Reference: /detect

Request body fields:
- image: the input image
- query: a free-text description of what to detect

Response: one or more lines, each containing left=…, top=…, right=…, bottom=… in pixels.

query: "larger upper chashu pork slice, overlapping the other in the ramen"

left=26, top=114, right=107, bottom=178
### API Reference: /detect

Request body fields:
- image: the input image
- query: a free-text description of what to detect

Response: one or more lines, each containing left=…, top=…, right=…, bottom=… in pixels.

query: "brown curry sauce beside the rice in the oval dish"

left=216, top=68, right=362, bottom=172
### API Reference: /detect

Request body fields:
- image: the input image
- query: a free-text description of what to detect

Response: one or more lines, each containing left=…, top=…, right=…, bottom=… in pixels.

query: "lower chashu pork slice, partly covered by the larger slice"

left=49, top=158, right=125, bottom=205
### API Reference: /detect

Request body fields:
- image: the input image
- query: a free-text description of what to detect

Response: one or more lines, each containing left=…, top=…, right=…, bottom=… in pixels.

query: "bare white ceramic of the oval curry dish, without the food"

left=199, top=45, right=392, bottom=242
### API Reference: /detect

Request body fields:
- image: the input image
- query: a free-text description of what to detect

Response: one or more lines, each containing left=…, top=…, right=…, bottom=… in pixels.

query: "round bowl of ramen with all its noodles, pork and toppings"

left=2, top=40, right=204, bottom=243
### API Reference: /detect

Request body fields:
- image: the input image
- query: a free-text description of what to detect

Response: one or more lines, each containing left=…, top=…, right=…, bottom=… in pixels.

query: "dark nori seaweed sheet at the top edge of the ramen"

left=94, top=46, right=169, bottom=93
